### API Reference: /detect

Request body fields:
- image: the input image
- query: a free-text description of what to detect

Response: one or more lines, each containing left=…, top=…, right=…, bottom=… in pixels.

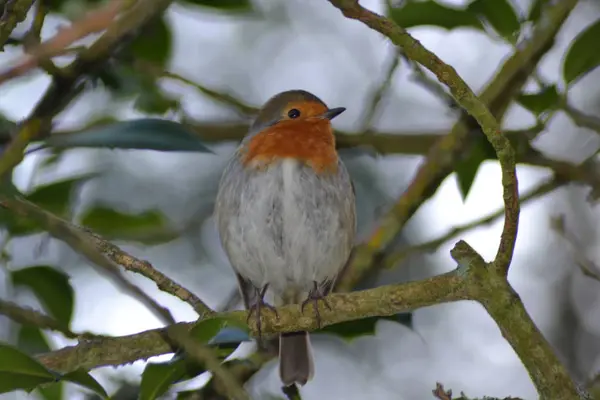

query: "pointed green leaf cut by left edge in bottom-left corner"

left=0, top=342, right=57, bottom=394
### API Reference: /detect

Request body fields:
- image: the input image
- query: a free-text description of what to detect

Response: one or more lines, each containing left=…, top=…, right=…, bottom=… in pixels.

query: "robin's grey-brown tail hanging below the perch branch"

left=279, top=331, right=314, bottom=386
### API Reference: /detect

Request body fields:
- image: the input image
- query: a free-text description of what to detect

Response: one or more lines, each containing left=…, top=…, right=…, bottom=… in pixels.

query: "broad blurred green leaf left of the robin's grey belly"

left=81, top=206, right=179, bottom=244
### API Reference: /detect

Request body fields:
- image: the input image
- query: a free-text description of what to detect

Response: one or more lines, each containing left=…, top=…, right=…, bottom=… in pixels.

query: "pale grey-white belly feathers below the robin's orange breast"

left=218, top=155, right=355, bottom=290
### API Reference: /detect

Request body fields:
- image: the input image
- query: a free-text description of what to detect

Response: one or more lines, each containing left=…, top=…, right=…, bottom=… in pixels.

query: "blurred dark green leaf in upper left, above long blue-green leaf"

left=131, top=16, right=173, bottom=67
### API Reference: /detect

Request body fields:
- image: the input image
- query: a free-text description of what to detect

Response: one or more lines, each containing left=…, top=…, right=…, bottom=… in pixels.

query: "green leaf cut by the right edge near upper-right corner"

left=563, top=20, right=600, bottom=85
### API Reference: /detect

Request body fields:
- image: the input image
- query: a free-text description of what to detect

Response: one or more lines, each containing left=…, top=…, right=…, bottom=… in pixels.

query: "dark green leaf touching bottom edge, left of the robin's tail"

left=139, top=360, right=186, bottom=400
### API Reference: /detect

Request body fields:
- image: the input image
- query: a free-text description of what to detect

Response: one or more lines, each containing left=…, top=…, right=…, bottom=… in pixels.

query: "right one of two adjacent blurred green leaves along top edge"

left=468, top=0, right=521, bottom=43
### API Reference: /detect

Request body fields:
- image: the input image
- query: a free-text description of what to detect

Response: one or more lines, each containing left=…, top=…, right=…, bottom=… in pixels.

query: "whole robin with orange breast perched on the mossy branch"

left=215, top=90, right=356, bottom=387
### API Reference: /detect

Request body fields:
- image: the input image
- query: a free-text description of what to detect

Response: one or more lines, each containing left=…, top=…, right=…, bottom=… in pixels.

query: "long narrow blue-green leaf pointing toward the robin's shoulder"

left=38, top=118, right=213, bottom=154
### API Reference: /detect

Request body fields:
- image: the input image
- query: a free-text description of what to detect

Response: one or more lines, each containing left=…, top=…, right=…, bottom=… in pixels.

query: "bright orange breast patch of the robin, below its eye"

left=242, top=119, right=338, bottom=173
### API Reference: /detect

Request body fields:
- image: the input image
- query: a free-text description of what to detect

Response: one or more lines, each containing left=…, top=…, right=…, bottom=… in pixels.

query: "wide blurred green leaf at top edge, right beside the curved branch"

left=388, top=0, right=483, bottom=29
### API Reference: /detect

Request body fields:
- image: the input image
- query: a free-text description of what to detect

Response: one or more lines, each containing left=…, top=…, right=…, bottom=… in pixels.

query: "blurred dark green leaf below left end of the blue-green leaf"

left=25, top=174, right=96, bottom=217
